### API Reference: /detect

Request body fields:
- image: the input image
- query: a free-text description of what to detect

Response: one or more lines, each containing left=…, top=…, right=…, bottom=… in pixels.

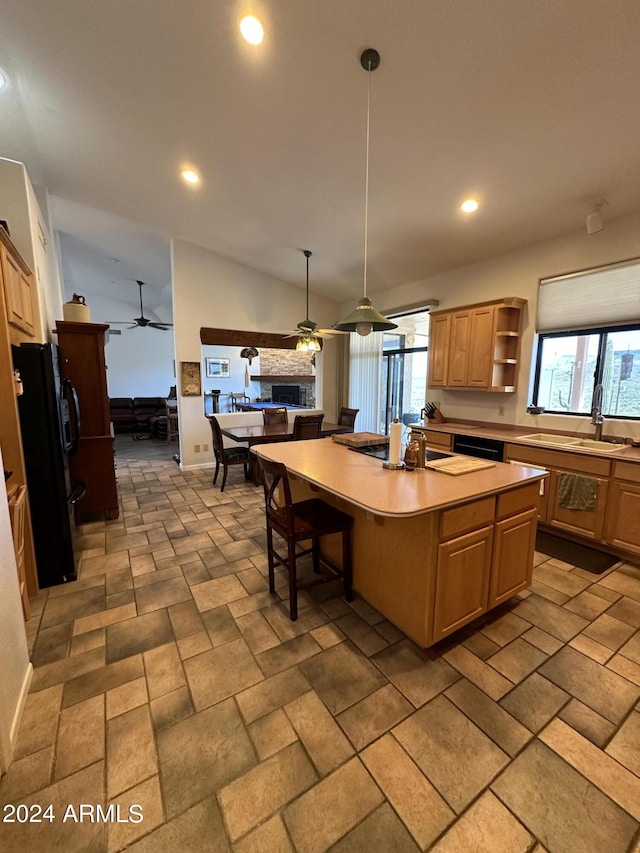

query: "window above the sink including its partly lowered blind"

left=533, top=259, right=640, bottom=418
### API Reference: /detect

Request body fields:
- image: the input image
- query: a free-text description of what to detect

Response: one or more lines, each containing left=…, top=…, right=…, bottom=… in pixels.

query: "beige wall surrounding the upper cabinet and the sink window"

left=356, top=214, right=640, bottom=437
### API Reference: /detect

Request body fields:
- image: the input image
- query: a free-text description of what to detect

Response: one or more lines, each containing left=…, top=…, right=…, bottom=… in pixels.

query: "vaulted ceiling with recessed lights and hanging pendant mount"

left=0, top=0, right=640, bottom=310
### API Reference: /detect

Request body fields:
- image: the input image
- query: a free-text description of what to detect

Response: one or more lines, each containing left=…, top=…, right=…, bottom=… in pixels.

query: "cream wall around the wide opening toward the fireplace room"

left=171, top=240, right=339, bottom=467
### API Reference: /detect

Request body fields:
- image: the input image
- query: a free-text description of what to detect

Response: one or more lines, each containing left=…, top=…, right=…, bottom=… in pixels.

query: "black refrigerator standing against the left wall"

left=12, top=343, right=85, bottom=587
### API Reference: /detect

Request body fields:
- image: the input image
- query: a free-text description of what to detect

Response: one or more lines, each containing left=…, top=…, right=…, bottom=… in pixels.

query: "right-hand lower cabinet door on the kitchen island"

left=489, top=509, right=537, bottom=607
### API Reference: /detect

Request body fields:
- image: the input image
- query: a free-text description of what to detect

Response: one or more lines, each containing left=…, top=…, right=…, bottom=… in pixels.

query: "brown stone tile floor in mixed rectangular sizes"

left=0, top=442, right=640, bottom=853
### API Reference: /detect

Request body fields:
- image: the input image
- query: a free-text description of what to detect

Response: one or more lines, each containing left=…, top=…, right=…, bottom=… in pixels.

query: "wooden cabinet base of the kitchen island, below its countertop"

left=291, top=474, right=539, bottom=648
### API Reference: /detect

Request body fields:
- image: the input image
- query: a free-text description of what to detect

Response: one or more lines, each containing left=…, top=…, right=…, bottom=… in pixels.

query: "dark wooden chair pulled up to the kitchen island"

left=258, top=456, right=353, bottom=622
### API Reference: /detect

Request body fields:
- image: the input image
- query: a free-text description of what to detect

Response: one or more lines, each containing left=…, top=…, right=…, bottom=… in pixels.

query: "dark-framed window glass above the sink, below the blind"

left=534, top=325, right=640, bottom=418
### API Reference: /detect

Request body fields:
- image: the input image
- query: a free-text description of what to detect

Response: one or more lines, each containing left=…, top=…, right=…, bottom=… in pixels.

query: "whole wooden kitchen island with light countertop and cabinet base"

left=256, top=439, right=547, bottom=647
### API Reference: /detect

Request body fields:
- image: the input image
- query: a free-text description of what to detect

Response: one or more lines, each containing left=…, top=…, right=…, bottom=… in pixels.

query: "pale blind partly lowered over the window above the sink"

left=536, top=260, right=640, bottom=332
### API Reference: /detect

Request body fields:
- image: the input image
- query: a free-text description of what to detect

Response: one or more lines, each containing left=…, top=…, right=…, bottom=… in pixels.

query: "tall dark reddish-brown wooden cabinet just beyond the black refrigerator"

left=56, top=321, right=118, bottom=523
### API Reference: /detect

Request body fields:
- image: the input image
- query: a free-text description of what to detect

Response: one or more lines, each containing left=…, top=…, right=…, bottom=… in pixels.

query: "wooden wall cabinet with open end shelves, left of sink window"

left=429, top=296, right=526, bottom=391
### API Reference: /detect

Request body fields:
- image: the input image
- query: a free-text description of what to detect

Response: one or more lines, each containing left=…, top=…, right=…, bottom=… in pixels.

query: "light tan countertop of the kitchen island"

left=256, top=439, right=547, bottom=518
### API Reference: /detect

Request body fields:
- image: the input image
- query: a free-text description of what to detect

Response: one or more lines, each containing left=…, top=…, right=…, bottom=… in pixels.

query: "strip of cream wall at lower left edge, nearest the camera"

left=0, top=446, right=33, bottom=770
